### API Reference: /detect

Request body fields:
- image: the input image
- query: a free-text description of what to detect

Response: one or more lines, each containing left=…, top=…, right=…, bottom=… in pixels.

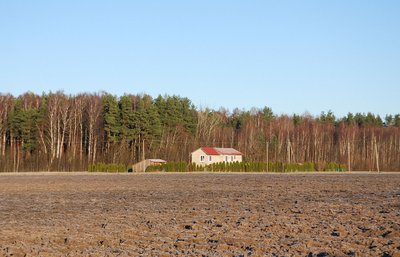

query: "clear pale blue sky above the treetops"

left=0, top=0, right=400, bottom=116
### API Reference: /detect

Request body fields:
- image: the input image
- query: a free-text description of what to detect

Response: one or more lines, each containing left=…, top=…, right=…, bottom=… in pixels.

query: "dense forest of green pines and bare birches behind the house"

left=0, top=92, right=400, bottom=172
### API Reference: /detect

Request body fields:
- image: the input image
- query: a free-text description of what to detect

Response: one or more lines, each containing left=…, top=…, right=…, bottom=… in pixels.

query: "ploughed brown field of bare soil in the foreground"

left=0, top=173, right=400, bottom=256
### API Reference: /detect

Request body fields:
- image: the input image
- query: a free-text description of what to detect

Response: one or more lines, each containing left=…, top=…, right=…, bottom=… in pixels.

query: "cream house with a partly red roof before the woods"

left=191, top=147, right=243, bottom=166
